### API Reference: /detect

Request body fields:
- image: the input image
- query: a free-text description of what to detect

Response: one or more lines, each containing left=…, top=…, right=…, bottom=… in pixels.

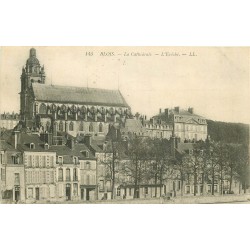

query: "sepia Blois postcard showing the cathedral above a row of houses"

left=0, top=46, right=250, bottom=204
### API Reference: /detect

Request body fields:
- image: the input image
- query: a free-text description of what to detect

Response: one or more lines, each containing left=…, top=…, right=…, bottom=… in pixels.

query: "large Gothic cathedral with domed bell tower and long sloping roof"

left=20, top=48, right=132, bottom=144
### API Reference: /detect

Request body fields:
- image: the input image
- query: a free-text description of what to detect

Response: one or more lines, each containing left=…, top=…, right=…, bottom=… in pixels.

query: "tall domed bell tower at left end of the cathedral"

left=20, top=48, right=45, bottom=122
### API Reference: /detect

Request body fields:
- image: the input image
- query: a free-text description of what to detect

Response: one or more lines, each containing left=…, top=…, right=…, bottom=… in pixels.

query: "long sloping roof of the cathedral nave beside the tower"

left=33, top=83, right=129, bottom=107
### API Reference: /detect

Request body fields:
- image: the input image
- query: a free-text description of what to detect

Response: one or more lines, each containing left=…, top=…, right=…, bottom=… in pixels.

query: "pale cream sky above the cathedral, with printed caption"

left=0, top=46, right=250, bottom=123
